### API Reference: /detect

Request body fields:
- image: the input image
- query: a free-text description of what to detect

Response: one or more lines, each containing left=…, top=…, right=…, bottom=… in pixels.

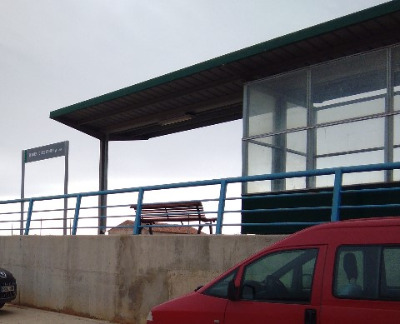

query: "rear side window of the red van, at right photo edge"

left=333, top=245, right=400, bottom=300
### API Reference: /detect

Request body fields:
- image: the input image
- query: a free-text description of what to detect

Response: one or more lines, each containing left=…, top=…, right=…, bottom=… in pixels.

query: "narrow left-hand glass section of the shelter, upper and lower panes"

left=244, top=71, right=308, bottom=192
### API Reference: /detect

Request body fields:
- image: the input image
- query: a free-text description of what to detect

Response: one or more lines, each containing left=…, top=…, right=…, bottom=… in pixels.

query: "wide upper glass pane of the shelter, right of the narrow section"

left=311, top=51, right=387, bottom=124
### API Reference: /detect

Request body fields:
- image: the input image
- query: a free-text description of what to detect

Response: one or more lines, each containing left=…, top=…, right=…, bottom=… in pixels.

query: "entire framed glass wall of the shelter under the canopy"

left=243, top=46, right=400, bottom=193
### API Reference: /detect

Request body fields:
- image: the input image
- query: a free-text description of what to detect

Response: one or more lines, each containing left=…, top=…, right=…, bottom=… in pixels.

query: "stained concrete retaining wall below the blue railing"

left=0, top=235, right=283, bottom=324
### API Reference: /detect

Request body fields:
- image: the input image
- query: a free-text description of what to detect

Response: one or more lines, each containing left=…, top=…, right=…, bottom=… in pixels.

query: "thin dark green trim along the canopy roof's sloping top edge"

left=50, top=0, right=400, bottom=119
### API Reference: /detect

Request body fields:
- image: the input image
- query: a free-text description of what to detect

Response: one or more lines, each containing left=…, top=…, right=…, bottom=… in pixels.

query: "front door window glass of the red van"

left=240, top=249, right=318, bottom=303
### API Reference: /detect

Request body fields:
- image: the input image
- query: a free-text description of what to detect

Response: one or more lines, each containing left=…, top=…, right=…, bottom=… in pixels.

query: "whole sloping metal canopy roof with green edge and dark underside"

left=50, top=0, right=400, bottom=141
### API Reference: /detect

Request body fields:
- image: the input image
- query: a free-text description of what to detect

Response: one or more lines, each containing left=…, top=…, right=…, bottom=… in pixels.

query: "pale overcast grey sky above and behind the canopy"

left=0, top=0, right=386, bottom=200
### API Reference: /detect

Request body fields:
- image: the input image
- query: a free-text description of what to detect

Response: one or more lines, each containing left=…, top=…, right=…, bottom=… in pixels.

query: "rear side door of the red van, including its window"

left=322, top=244, right=400, bottom=324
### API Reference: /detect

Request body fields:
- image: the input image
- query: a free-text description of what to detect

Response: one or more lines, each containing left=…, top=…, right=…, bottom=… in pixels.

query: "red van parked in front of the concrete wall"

left=147, top=217, right=400, bottom=324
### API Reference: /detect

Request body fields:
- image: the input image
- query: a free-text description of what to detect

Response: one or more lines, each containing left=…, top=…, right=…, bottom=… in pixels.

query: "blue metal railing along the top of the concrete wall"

left=0, top=163, right=400, bottom=235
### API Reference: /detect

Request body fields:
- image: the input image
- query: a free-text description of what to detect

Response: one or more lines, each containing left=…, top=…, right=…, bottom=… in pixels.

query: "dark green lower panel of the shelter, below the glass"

left=242, top=182, right=400, bottom=234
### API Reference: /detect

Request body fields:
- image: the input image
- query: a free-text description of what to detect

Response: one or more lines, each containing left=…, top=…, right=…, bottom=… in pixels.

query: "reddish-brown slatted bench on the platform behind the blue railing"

left=131, top=200, right=217, bottom=234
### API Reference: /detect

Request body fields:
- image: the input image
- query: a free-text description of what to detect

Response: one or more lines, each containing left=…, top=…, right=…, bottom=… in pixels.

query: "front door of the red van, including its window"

left=224, top=246, right=326, bottom=324
